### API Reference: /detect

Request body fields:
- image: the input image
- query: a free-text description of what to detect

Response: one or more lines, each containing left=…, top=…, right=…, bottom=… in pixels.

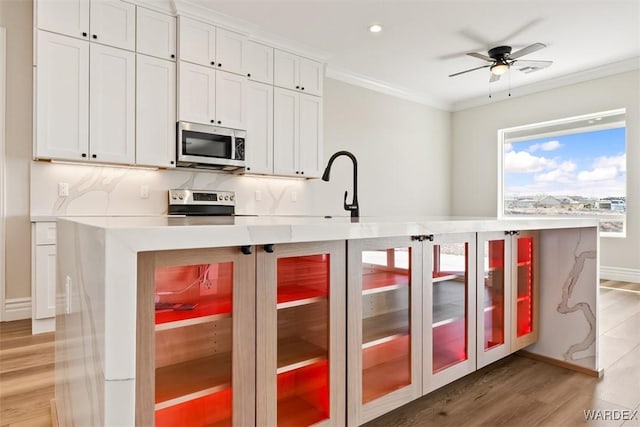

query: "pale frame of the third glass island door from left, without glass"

left=347, top=236, right=423, bottom=426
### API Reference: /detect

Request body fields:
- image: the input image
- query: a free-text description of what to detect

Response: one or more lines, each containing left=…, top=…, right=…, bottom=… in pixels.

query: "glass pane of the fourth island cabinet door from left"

left=432, top=243, right=469, bottom=373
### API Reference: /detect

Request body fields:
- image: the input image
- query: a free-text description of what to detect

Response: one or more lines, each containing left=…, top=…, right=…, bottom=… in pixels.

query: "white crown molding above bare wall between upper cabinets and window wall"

left=325, top=64, right=451, bottom=111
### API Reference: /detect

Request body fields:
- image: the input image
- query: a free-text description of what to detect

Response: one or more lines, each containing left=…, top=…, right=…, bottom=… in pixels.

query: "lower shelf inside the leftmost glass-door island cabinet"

left=155, top=353, right=231, bottom=410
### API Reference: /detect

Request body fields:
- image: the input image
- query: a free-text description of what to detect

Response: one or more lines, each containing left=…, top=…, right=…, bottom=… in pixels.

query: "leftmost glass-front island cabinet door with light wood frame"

left=137, top=248, right=255, bottom=426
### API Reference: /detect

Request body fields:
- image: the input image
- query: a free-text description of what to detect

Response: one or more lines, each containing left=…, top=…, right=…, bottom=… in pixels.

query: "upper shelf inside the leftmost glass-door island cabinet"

left=155, top=295, right=232, bottom=331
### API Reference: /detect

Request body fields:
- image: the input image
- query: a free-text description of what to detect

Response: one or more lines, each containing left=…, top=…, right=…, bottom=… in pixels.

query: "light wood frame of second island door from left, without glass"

left=256, top=241, right=346, bottom=426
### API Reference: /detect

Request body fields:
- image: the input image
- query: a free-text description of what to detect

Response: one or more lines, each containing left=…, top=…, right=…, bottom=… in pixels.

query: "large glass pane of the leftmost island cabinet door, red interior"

left=155, top=262, right=233, bottom=426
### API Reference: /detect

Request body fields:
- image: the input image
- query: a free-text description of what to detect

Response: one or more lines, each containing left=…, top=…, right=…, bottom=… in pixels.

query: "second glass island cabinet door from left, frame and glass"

left=257, top=242, right=345, bottom=426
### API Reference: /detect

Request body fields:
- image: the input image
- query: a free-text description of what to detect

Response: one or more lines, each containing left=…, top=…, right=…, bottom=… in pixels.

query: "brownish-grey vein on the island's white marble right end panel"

left=557, top=233, right=597, bottom=361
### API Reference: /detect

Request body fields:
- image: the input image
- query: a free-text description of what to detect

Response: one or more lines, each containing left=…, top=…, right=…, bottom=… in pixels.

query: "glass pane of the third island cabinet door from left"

left=362, top=248, right=411, bottom=403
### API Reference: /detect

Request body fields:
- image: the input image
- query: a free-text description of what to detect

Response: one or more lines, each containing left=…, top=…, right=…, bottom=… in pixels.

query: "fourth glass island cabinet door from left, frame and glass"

left=423, top=233, right=476, bottom=393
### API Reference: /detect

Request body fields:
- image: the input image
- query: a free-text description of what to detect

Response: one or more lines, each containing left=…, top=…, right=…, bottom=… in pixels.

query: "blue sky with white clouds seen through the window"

left=503, top=128, right=626, bottom=197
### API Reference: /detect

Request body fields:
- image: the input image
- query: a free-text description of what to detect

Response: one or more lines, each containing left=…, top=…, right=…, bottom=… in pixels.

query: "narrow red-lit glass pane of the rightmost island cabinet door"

left=516, top=237, right=533, bottom=337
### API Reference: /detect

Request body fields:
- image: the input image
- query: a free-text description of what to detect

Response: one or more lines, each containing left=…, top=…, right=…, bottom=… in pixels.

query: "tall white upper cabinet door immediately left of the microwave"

left=136, top=54, right=176, bottom=167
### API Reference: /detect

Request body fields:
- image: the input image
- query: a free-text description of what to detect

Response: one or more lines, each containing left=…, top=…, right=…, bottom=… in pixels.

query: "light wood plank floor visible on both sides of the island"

left=0, top=282, right=640, bottom=427
